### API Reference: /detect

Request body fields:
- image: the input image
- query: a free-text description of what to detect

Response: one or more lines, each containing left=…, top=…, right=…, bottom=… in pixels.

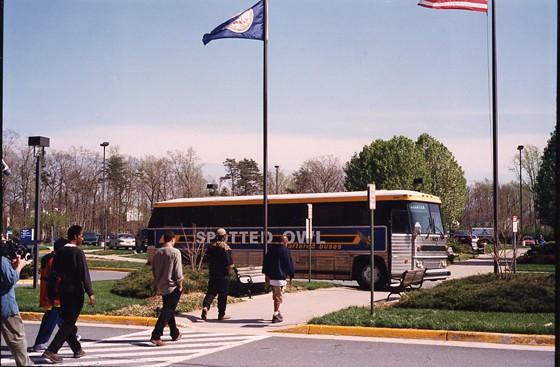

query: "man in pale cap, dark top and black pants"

left=201, top=228, right=233, bottom=320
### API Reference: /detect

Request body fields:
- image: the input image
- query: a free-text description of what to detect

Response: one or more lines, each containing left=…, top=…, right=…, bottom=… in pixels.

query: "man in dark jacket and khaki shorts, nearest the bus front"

left=263, top=236, right=294, bottom=324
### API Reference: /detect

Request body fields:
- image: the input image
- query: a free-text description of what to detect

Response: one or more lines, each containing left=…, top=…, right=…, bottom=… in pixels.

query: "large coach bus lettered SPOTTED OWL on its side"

left=148, top=190, right=450, bottom=288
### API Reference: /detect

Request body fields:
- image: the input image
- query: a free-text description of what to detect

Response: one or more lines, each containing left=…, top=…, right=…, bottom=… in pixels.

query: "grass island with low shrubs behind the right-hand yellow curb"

left=309, top=273, right=555, bottom=335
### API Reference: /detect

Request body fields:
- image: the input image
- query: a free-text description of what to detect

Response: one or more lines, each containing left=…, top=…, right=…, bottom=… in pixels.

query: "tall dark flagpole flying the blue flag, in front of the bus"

left=263, top=0, right=268, bottom=258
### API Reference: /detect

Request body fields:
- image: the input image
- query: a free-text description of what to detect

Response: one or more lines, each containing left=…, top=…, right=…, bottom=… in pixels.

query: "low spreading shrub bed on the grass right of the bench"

left=396, top=274, right=555, bottom=313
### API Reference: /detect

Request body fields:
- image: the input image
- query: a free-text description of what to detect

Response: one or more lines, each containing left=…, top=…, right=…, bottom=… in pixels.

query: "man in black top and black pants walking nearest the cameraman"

left=43, top=225, right=95, bottom=363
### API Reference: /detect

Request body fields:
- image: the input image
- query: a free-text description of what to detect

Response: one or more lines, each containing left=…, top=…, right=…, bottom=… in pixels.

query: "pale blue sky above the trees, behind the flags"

left=3, top=0, right=557, bottom=182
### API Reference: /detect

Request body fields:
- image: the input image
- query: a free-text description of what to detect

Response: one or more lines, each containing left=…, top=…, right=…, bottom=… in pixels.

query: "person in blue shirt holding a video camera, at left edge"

left=1, top=242, right=33, bottom=366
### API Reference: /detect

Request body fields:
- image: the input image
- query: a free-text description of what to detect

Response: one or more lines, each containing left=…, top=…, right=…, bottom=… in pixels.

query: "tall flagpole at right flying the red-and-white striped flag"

left=491, top=0, right=499, bottom=274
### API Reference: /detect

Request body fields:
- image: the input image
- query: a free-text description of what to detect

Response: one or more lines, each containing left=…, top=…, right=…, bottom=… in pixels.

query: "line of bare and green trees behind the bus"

left=2, top=130, right=556, bottom=242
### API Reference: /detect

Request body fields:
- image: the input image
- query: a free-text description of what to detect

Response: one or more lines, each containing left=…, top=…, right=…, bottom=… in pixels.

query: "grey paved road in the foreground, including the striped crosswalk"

left=1, top=322, right=554, bottom=367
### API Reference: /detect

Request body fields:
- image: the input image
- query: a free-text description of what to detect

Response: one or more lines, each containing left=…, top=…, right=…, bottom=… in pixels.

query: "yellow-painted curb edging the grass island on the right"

left=271, top=325, right=556, bottom=346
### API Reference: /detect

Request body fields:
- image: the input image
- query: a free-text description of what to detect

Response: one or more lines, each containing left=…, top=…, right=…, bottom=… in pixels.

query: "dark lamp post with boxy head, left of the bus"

left=28, top=136, right=50, bottom=289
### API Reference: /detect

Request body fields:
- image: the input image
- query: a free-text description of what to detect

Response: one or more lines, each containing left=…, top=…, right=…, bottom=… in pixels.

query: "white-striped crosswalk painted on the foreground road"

left=2, top=330, right=268, bottom=367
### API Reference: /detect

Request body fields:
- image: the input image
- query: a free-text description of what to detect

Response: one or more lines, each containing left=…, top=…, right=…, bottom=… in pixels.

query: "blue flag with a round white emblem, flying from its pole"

left=202, top=0, right=264, bottom=45
